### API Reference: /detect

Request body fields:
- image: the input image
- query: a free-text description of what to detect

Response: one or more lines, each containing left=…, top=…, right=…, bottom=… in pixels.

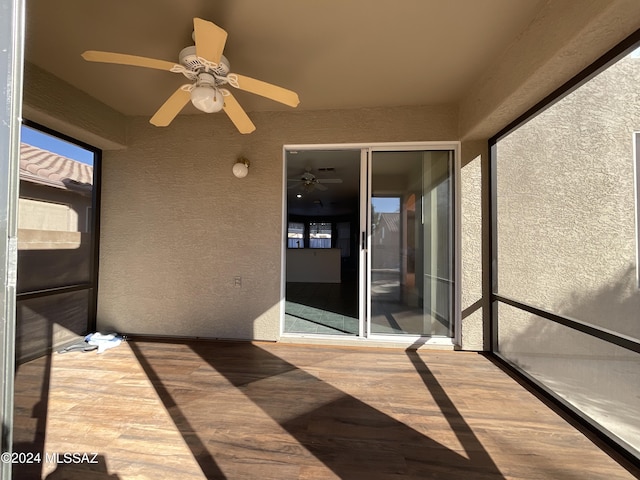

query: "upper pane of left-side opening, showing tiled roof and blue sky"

left=18, top=126, right=93, bottom=293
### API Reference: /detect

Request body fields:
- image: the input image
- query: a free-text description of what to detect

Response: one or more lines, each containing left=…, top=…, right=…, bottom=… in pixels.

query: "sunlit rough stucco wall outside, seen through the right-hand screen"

left=497, top=57, right=640, bottom=353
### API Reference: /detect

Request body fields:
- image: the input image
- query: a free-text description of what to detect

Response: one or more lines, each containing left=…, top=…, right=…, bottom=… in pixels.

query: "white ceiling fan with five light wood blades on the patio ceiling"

left=82, top=18, right=300, bottom=133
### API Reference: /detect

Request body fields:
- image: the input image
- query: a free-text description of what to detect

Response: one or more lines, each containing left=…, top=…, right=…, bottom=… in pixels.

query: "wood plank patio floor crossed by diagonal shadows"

left=14, top=340, right=638, bottom=480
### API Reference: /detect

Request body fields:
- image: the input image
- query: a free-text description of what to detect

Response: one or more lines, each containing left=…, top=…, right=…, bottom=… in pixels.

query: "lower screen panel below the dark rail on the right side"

left=498, top=304, right=640, bottom=455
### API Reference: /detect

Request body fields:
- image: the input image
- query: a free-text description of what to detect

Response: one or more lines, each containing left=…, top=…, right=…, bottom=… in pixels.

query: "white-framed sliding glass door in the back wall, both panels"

left=282, top=145, right=457, bottom=339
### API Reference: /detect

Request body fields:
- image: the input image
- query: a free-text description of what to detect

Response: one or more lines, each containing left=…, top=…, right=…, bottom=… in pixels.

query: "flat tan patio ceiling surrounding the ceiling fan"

left=25, top=0, right=545, bottom=116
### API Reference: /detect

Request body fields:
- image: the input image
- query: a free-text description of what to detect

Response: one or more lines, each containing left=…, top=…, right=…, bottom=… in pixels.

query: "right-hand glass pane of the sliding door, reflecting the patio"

left=370, top=151, right=454, bottom=336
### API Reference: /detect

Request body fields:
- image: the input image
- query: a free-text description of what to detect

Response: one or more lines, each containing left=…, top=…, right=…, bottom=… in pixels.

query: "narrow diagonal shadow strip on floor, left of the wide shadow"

left=128, top=341, right=227, bottom=480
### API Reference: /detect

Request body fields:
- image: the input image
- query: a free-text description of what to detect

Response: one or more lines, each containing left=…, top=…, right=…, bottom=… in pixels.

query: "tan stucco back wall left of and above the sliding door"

left=98, top=106, right=457, bottom=340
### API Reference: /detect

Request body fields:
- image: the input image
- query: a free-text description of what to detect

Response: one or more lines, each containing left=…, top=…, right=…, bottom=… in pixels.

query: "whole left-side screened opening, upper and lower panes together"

left=16, top=126, right=94, bottom=362
